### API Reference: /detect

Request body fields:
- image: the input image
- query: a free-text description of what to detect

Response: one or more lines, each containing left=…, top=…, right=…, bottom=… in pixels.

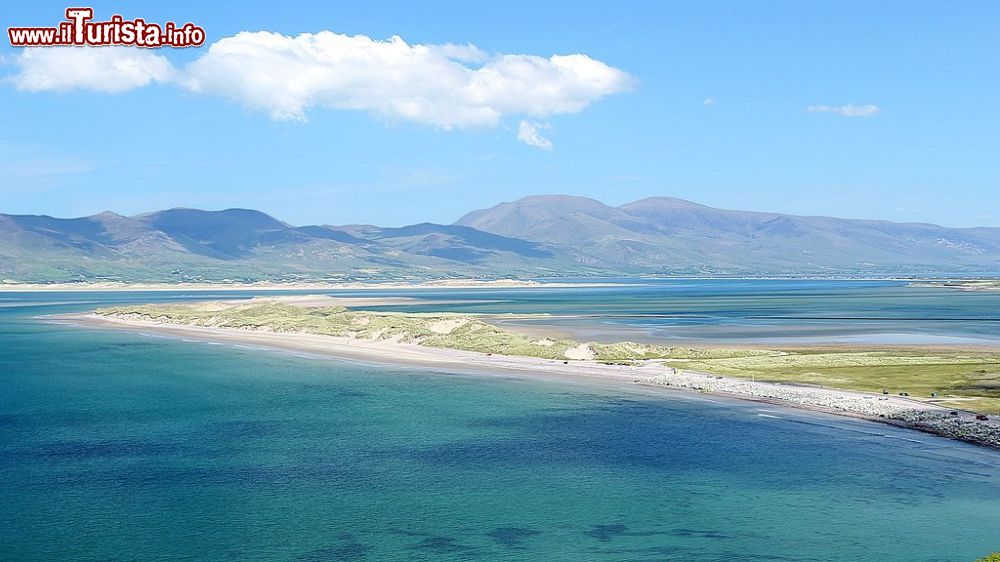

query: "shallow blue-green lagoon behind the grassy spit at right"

left=408, top=279, right=1000, bottom=347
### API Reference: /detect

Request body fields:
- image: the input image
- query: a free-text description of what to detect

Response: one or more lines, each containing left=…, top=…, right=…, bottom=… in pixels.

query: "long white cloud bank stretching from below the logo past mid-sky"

left=10, top=31, right=634, bottom=144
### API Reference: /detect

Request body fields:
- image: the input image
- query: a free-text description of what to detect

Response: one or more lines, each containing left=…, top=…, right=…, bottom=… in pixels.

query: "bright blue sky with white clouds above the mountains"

left=0, top=0, right=1000, bottom=226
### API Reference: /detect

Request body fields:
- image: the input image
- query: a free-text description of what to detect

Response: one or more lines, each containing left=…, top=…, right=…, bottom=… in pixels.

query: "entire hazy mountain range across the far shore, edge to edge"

left=0, top=195, right=1000, bottom=282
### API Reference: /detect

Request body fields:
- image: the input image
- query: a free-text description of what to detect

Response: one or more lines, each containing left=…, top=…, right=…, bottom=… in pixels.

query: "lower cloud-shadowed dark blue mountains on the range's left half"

left=0, top=209, right=587, bottom=282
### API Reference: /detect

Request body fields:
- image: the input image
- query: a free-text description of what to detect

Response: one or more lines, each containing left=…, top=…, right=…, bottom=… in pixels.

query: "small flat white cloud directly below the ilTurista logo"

left=8, top=47, right=174, bottom=93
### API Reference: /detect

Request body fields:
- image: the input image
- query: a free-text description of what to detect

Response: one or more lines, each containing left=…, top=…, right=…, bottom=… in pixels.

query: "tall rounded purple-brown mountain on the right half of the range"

left=457, top=195, right=1000, bottom=274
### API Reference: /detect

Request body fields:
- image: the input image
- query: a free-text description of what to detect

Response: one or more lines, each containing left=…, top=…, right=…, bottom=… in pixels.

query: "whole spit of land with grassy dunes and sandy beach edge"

left=64, top=296, right=1000, bottom=448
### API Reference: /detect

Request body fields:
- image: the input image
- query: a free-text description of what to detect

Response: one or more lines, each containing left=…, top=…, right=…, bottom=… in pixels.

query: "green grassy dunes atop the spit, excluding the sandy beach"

left=97, top=301, right=1000, bottom=413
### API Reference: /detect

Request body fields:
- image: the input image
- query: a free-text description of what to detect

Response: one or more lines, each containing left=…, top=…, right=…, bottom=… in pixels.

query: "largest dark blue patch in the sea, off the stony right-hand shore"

left=388, top=400, right=984, bottom=500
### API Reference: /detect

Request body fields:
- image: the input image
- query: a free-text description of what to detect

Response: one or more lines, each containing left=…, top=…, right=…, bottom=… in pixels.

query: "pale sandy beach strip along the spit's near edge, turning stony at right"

left=58, top=313, right=1000, bottom=449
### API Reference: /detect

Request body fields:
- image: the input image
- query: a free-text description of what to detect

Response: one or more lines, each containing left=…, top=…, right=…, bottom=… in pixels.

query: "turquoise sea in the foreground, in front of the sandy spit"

left=0, top=287, right=1000, bottom=561
